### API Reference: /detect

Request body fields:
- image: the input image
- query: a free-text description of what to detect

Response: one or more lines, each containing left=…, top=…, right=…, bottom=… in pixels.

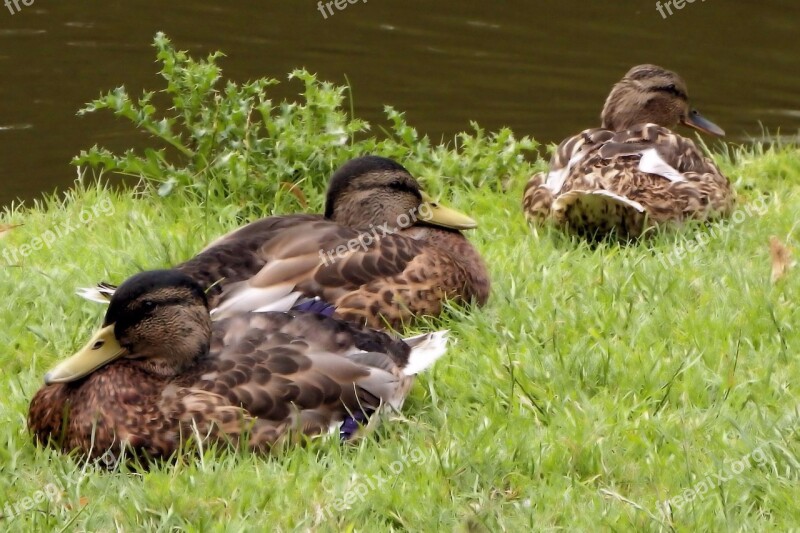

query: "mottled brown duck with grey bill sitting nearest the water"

left=523, top=65, right=734, bottom=237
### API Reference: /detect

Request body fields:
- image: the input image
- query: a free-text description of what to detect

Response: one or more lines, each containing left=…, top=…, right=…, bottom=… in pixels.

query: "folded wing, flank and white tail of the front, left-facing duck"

left=162, top=313, right=446, bottom=449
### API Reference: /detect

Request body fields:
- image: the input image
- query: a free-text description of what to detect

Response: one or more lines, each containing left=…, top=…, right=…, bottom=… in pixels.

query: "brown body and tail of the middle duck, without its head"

left=80, top=215, right=478, bottom=328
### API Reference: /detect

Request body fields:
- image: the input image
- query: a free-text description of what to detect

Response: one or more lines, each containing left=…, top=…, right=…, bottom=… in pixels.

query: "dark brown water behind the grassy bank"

left=0, top=0, right=800, bottom=205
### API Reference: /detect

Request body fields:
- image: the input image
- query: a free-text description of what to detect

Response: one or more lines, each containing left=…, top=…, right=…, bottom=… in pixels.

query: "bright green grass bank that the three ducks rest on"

left=0, top=35, right=800, bottom=531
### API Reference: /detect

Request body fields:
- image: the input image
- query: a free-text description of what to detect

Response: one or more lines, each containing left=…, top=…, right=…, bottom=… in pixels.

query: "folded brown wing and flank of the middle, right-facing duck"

left=209, top=222, right=469, bottom=328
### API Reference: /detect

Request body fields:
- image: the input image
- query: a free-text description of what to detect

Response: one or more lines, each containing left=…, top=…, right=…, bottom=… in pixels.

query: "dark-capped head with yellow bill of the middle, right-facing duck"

left=325, top=156, right=478, bottom=230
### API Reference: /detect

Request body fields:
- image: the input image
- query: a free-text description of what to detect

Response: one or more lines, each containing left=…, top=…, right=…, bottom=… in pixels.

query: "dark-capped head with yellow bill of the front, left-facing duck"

left=44, top=270, right=211, bottom=385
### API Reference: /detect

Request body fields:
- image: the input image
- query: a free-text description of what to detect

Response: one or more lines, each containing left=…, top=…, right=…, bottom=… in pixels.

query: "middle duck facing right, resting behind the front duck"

left=83, top=156, right=490, bottom=328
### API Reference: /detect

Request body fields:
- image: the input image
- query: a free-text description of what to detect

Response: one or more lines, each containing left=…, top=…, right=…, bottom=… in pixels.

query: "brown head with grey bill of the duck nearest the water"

left=602, top=65, right=725, bottom=137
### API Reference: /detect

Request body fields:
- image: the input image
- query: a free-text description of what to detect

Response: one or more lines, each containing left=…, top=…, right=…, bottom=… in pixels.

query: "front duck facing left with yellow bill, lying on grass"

left=28, top=270, right=446, bottom=458
